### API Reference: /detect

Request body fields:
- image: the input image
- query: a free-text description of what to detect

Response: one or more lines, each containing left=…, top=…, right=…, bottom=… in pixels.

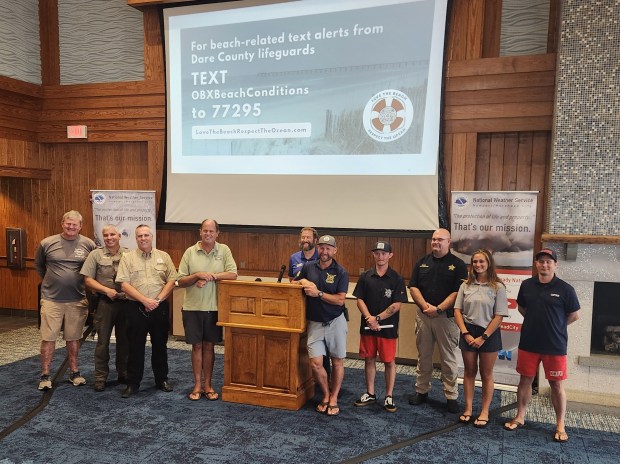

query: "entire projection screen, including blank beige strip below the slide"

left=163, top=0, right=447, bottom=230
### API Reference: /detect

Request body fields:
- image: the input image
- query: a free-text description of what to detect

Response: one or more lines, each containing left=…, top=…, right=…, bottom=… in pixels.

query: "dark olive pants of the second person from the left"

left=93, top=296, right=129, bottom=382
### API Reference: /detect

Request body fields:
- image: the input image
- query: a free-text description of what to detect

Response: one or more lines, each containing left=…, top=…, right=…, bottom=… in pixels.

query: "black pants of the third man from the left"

left=127, top=301, right=170, bottom=387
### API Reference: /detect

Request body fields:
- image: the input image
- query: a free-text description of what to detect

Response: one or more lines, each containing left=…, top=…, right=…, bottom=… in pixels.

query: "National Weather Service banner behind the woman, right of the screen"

left=451, top=192, right=538, bottom=385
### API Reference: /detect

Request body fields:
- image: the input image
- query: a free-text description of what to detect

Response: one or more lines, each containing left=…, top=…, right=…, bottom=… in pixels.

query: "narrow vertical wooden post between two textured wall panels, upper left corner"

left=39, top=0, right=60, bottom=85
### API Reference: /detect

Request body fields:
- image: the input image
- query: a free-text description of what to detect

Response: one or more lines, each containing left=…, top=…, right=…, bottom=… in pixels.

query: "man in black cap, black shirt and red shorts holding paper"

left=353, top=241, right=407, bottom=412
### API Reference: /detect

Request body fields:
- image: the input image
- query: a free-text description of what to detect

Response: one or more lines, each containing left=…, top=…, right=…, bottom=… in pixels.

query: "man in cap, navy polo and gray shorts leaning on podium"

left=295, top=235, right=349, bottom=416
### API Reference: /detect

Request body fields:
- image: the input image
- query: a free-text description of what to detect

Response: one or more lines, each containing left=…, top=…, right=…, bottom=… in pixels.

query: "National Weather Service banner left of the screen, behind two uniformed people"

left=91, top=190, right=156, bottom=249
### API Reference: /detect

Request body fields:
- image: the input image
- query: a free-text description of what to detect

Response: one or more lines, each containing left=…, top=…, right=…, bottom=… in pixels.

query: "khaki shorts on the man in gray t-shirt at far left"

left=41, top=298, right=88, bottom=342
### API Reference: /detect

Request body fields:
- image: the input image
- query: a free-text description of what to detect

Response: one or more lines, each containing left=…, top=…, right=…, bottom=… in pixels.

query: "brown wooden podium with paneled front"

left=217, top=280, right=314, bottom=410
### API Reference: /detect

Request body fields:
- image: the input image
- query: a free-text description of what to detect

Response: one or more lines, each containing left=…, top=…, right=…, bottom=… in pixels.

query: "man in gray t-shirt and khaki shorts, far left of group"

left=35, top=211, right=96, bottom=390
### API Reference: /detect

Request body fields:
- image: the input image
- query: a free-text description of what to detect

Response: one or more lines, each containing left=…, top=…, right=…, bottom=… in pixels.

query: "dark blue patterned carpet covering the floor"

left=0, top=320, right=620, bottom=464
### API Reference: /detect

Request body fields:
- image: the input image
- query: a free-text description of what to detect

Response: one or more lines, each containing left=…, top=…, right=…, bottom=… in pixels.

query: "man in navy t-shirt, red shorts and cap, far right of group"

left=504, top=248, right=580, bottom=443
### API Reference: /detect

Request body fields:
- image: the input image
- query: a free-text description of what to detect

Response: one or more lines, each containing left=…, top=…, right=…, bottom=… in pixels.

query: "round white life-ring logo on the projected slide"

left=363, top=89, right=413, bottom=142
